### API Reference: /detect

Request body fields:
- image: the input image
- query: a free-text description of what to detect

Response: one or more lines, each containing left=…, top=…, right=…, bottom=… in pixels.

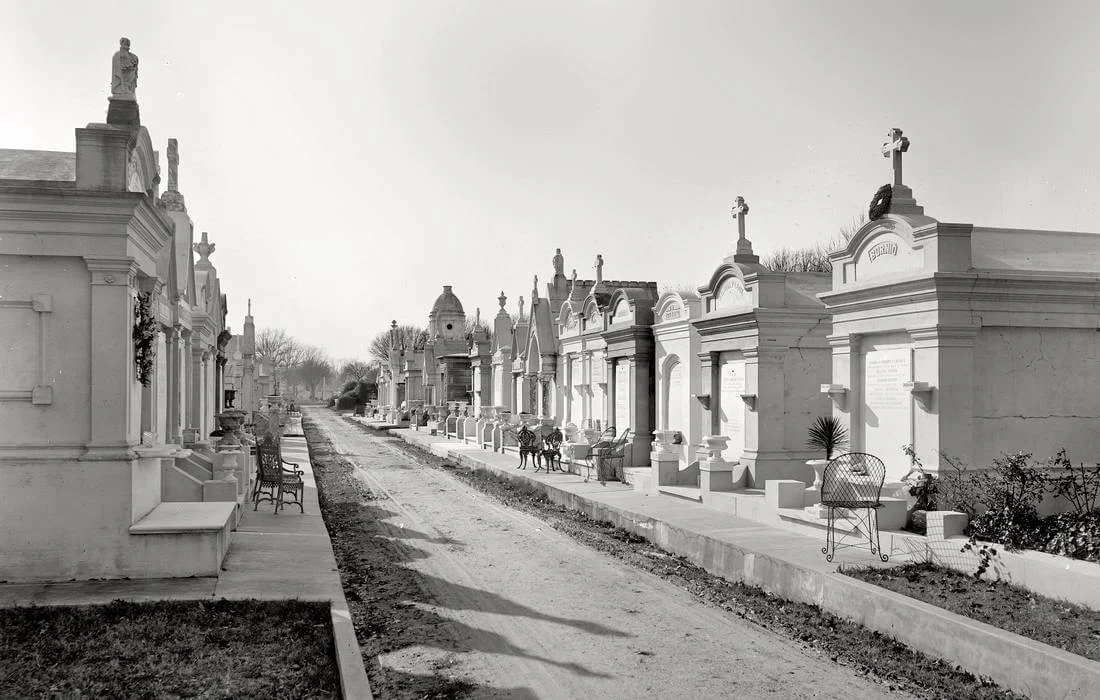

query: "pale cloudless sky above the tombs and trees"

left=0, top=0, right=1100, bottom=359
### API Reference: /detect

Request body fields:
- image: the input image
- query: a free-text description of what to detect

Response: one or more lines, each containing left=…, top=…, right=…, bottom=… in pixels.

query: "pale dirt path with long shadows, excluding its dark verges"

left=309, top=409, right=899, bottom=698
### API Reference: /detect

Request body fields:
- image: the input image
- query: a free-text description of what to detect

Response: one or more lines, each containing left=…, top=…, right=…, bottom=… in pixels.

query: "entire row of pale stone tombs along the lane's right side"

left=375, top=140, right=1100, bottom=519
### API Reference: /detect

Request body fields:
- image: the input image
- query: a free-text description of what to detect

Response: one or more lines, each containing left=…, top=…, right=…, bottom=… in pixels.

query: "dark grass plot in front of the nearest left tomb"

left=0, top=600, right=340, bottom=698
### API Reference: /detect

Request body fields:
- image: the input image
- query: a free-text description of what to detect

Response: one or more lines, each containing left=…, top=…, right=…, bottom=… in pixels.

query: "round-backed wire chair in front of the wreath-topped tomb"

left=822, top=452, right=890, bottom=561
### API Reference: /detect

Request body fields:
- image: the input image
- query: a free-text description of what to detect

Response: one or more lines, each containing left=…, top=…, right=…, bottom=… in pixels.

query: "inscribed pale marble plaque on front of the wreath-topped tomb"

left=862, top=348, right=913, bottom=480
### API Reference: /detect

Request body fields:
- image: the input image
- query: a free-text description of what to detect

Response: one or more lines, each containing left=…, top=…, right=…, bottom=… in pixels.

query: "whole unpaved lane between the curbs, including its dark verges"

left=307, top=411, right=1011, bottom=698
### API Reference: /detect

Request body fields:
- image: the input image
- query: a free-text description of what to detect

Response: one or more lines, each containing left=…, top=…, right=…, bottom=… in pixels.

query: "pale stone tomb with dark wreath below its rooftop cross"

left=821, top=130, right=1100, bottom=481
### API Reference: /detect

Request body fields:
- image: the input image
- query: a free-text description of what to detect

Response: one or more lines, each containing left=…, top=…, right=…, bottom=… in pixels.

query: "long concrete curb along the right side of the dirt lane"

left=389, top=430, right=1100, bottom=699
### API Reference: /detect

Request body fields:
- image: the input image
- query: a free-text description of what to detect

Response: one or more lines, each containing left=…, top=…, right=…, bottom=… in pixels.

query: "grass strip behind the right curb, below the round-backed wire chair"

left=840, top=562, right=1100, bottom=661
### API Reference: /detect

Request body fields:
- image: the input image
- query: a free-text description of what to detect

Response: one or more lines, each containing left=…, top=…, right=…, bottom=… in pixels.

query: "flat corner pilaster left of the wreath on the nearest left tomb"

left=85, top=258, right=141, bottom=458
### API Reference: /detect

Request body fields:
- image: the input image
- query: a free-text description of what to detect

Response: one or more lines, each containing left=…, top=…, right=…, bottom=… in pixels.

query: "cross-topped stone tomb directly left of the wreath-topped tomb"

left=693, top=197, right=832, bottom=500
